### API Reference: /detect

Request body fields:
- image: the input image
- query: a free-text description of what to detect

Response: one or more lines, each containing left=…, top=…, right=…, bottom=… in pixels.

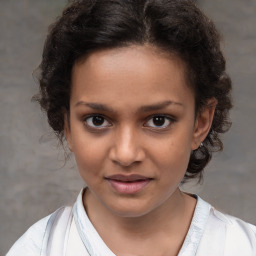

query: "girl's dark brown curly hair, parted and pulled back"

left=34, top=0, right=232, bottom=182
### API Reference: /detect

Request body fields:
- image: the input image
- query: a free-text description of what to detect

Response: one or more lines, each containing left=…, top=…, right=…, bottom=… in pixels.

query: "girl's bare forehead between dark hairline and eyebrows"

left=71, top=46, right=193, bottom=109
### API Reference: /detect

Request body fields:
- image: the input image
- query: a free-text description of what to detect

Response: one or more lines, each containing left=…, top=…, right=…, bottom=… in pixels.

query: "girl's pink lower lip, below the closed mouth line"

left=107, top=179, right=151, bottom=194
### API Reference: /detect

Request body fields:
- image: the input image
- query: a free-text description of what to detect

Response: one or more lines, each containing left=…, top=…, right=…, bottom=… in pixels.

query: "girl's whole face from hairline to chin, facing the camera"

left=65, top=46, right=211, bottom=216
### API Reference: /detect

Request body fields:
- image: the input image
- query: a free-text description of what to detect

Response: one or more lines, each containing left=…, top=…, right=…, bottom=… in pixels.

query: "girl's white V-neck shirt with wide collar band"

left=6, top=191, right=256, bottom=256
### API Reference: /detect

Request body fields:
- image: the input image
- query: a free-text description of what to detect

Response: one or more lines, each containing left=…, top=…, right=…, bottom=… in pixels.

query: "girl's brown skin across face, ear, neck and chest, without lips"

left=65, top=45, right=216, bottom=256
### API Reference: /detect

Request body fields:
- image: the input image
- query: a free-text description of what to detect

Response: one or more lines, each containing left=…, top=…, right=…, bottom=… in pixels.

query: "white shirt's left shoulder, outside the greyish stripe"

left=6, top=207, right=69, bottom=256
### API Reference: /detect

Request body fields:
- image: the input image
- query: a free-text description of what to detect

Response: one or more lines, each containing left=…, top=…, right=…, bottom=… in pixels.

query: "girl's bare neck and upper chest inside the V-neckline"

left=84, top=189, right=196, bottom=256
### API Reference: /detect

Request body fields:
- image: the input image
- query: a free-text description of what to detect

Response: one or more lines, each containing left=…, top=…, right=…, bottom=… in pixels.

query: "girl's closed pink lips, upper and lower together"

left=106, top=174, right=152, bottom=194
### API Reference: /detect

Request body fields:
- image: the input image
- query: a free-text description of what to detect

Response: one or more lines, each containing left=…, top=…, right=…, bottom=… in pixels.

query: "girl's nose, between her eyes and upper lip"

left=109, top=126, right=145, bottom=167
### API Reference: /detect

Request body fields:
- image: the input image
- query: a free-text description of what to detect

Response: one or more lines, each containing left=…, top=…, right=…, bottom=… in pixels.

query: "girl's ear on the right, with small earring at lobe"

left=191, top=98, right=218, bottom=150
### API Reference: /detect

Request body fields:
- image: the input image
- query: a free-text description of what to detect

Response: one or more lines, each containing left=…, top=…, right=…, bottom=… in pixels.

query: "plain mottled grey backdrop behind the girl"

left=0, top=0, right=256, bottom=255
